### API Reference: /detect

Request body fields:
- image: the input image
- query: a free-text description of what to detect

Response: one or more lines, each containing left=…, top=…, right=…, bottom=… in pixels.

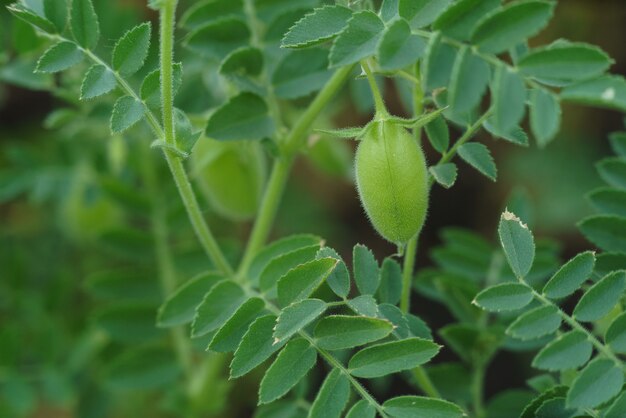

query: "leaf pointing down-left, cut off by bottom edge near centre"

left=308, top=369, right=350, bottom=418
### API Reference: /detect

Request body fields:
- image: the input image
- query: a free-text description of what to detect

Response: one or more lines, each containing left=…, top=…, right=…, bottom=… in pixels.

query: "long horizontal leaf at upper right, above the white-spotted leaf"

left=517, top=40, right=613, bottom=81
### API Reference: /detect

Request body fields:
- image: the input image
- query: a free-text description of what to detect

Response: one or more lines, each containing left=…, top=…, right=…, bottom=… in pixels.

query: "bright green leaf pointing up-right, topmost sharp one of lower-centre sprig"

left=277, top=257, right=338, bottom=306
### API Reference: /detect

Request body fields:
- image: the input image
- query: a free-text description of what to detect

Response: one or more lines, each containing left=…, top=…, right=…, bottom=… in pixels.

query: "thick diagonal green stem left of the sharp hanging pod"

left=237, top=66, right=354, bottom=279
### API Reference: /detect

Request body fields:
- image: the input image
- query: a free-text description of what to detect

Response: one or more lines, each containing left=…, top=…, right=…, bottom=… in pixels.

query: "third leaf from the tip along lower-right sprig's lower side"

left=533, top=331, right=593, bottom=371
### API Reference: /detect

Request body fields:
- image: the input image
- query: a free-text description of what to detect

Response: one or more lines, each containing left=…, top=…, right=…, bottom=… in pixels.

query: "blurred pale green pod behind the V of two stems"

left=191, top=138, right=267, bottom=221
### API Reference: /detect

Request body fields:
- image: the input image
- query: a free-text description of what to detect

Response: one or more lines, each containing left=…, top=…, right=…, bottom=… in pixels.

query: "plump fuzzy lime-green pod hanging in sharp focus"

left=355, top=121, right=428, bottom=244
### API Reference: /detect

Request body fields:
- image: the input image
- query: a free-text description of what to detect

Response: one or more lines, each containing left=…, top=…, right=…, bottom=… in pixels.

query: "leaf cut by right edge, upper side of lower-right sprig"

left=574, top=271, right=626, bottom=322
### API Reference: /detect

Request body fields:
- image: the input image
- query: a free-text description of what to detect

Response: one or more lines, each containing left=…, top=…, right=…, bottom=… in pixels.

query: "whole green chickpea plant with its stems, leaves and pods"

left=3, top=0, right=626, bottom=418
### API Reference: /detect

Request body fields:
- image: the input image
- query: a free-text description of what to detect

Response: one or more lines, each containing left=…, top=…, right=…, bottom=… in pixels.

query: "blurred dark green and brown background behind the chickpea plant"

left=0, top=0, right=626, bottom=417
